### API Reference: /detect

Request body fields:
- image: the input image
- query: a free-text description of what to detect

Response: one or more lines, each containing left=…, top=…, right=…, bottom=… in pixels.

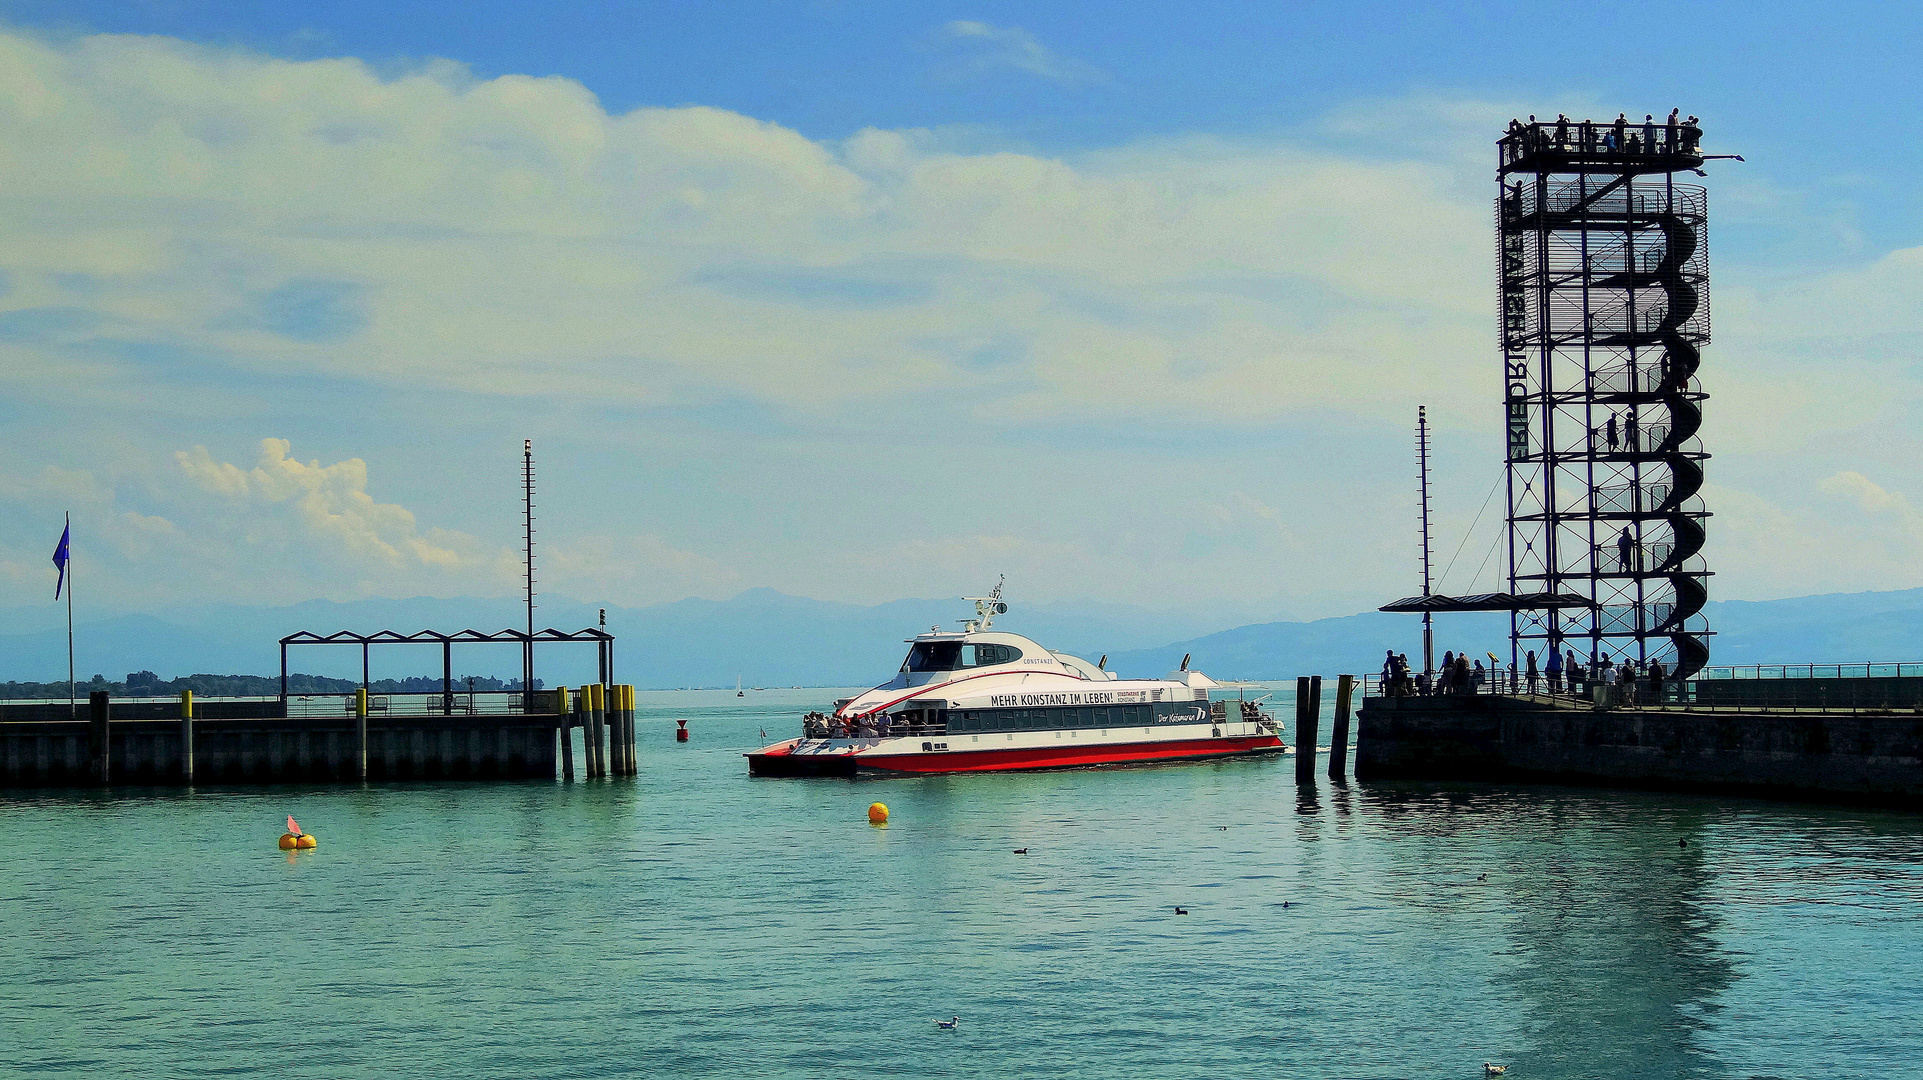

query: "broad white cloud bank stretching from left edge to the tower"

left=0, top=23, right=1490, bottom=428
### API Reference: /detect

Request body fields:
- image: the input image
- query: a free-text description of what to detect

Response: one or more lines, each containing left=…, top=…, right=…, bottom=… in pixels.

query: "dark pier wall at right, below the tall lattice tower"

left=1356, top=696, right=1923, bottom=807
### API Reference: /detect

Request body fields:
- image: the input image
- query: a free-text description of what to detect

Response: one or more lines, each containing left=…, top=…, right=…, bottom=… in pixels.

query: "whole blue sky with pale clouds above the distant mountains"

left=0, top=0, right=1923, bottom=626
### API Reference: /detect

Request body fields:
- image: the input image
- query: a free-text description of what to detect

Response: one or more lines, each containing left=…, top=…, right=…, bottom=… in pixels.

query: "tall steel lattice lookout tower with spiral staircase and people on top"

left=1496, top=117, right=1710, bottom=676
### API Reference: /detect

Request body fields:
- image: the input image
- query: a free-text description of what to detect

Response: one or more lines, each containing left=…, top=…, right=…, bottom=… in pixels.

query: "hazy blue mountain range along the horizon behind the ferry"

left=0, top=588, right=1923, bottom=688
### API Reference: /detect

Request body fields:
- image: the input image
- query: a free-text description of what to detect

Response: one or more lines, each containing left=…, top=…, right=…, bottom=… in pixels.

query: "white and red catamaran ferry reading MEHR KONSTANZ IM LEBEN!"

left=746, top=584, right=1285, bottom=776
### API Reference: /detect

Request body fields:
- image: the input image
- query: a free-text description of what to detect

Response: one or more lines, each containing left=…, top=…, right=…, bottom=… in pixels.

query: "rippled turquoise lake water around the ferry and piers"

left=0, top=690, right=1923, bottom=1080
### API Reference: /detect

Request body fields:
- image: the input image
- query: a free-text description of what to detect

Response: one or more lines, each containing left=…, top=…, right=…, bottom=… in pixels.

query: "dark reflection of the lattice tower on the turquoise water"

left=1363, top=786, right=1736, bottom=1078
